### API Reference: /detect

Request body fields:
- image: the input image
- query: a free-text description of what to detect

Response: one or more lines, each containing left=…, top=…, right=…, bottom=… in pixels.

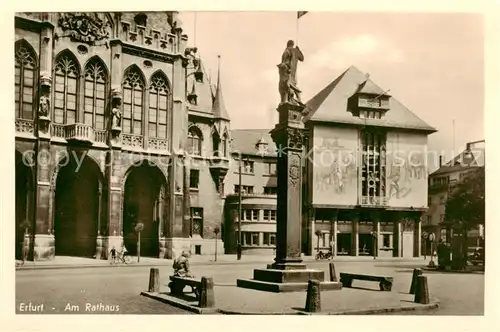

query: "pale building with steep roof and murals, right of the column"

left=303, top=66, right=436, bottom=257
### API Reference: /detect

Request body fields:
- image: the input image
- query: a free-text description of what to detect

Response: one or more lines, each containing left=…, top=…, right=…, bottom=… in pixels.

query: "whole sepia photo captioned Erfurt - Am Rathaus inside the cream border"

left=2, top=4, right=494, bottom=330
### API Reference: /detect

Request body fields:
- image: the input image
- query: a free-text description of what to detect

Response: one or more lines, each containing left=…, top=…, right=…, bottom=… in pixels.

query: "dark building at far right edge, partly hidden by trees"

left=422, top=140, right=485, bottom=252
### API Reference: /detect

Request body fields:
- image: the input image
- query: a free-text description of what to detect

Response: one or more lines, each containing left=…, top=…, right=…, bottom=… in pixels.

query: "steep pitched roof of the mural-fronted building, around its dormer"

left=304, top=66, right=436, bottom=133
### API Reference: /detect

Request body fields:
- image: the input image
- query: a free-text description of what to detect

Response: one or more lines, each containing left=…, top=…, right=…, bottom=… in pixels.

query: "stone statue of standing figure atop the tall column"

left=278, top=40, right=304, bottom=104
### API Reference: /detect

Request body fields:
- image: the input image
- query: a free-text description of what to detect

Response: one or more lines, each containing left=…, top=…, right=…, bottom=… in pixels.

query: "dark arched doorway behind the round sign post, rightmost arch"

left=123, top=164, right=166, bottom=258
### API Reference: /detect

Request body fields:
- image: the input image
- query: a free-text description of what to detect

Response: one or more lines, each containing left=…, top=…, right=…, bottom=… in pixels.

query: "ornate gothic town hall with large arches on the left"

left=14, top=12, right=231, bottom=260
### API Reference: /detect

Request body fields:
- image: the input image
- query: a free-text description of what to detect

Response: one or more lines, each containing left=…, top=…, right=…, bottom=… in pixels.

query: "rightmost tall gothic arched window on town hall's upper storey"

left=149, top=73, right=170, bottom=138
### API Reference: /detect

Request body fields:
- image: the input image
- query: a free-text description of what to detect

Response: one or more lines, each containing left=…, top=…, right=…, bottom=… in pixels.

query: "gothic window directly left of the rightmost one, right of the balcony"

left=122, top=67, right=145, bottom=135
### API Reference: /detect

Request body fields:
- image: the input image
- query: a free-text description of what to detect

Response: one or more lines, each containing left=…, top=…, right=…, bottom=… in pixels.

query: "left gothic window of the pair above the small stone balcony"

left=54, top=52, right=80, bottom=124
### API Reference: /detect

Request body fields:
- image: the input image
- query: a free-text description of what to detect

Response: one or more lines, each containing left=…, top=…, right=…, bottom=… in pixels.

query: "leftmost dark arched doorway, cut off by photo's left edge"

left=15, top=151, right=33, bottom=260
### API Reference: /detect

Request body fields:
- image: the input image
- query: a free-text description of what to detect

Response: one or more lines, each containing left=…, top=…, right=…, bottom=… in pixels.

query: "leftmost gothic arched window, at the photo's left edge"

left=14, top=41, right=36, bottom=120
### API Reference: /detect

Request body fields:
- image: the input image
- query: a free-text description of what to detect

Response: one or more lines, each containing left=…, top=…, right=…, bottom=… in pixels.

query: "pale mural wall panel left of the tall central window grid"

left=312, top=127, right=357, bottom=205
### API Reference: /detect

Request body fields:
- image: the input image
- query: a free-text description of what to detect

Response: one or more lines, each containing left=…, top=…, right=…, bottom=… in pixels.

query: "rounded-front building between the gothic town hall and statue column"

left=224, top=129, right=277, bottom=255
